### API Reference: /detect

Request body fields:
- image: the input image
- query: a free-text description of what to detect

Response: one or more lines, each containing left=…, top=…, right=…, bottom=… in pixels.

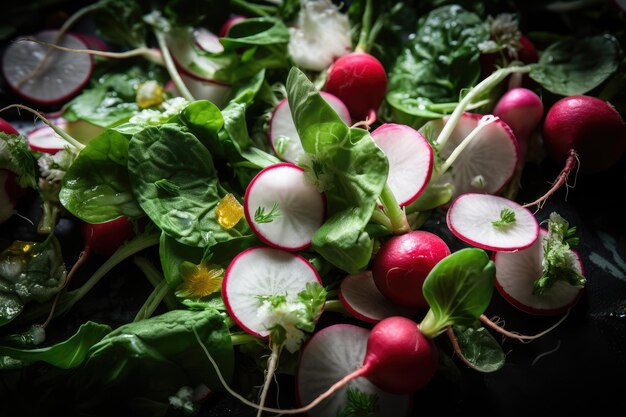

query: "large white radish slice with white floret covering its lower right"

left=222, top=247, right=322, bottom=337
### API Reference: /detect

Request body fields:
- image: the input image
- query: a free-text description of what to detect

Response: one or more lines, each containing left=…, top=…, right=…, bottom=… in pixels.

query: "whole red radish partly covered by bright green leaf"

left=372, top=230, right=450, bottom=308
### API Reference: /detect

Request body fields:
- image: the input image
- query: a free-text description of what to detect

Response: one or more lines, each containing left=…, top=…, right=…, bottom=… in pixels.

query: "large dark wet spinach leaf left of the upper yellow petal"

left=128, top=124, right=231, bottom=247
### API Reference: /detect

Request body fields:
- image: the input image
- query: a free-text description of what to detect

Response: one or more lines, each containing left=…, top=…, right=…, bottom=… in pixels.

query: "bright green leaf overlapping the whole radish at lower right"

left=420, top=248, right=495, bottom=337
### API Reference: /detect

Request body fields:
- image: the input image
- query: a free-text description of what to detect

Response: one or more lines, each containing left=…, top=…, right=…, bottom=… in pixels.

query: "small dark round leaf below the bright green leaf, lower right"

left=454, top=322, right=506, bottom=372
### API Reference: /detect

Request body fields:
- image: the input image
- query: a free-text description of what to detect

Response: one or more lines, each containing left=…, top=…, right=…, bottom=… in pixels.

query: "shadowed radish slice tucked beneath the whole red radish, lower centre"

left=339, top=271, right=417, bottom=323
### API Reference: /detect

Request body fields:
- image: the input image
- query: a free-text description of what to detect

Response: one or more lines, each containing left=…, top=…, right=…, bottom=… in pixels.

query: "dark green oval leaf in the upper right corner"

left=529, top=34, right=621, bottom=96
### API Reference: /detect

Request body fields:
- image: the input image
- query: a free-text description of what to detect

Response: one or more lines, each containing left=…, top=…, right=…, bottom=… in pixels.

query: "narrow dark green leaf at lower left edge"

left=0, top=321, right=111, bottom=369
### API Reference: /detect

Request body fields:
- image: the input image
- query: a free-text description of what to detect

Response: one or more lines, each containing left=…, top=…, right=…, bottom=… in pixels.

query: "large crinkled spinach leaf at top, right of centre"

left=386, top=5, right=489, bottom=127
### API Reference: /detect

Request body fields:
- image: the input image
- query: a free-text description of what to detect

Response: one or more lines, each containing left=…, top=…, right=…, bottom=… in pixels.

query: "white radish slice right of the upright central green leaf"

left=372, top=123, right=434, bottom=206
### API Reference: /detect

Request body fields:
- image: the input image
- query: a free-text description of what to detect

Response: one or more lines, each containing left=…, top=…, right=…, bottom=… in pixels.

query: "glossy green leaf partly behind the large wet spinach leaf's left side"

left=59, top=129, right=144, bottom=223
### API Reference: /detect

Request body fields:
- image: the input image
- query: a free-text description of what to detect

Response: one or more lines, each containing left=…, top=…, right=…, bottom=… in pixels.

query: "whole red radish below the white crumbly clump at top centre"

left=324, top=52, right=387, bottom=120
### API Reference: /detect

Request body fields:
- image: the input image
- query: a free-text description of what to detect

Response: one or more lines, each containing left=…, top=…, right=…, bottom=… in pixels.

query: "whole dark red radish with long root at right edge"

left=543, top=95, right=626, bottom=174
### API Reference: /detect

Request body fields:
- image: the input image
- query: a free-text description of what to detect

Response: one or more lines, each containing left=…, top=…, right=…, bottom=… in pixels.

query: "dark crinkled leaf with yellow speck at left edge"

left=0, top=234, right=66, bottom=326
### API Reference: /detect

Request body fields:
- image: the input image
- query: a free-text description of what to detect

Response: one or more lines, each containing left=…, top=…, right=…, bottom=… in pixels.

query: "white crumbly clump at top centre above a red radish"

left=288, top=0, right=352, bottom=71
